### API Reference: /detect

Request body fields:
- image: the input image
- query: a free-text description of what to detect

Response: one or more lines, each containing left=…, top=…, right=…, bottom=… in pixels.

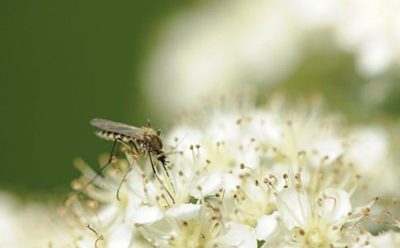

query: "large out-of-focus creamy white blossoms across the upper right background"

left=143, top=0, right=400, bottom=116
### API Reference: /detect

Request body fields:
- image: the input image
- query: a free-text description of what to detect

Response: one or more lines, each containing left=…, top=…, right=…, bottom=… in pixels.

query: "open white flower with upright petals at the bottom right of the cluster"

left=275, top=188, right=369, bottom=247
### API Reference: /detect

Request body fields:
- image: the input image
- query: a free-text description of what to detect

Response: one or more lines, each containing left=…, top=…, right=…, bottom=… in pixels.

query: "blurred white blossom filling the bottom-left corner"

left=0, top=192, right=96, bottom=248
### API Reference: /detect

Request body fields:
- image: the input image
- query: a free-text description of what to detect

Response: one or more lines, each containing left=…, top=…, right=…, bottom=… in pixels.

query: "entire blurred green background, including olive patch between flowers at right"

left=0, top=0, right=400, bottom=193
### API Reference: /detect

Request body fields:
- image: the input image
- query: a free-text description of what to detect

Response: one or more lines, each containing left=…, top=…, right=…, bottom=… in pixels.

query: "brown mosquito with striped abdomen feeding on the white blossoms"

left=66, top=119, right=175, bottom=203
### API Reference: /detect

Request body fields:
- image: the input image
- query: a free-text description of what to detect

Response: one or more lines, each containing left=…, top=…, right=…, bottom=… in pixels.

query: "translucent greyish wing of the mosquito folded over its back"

left=90, top=119, right=143, bottom=139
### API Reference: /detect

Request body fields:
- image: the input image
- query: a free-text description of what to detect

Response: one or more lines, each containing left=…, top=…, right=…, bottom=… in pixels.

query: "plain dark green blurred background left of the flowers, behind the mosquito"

left=0, top=0, right=188, bottom=192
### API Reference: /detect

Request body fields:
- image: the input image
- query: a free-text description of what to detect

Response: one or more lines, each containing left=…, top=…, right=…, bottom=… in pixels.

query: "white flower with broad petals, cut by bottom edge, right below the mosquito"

left=134, top=204, right=257, bottom=248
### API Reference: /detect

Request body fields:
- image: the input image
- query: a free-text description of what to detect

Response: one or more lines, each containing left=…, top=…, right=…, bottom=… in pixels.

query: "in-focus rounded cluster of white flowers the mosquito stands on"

left=62, top=98, right=399, bottom=247
